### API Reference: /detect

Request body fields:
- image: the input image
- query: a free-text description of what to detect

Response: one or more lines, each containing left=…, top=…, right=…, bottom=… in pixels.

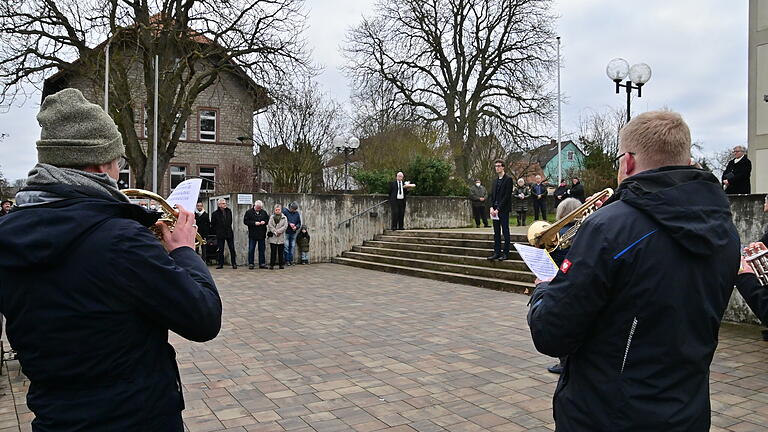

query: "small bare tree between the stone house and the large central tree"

left=255, top=80, right=344, bottom=192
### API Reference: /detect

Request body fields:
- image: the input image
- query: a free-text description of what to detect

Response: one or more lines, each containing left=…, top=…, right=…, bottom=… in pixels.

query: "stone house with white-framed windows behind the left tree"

left=43, top=41, right=271, bottom=197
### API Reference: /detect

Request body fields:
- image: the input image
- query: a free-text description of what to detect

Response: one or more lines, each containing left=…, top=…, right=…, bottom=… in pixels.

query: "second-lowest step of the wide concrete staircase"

left=342, top=251, right=535, bottom=282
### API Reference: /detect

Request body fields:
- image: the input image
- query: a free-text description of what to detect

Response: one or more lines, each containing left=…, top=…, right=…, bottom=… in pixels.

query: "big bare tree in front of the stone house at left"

left=0, top=0, right=308, bottom=187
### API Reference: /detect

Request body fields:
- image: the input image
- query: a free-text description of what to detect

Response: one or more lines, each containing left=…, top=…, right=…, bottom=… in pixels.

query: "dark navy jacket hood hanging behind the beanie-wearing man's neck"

left=0, top=185, right=160, bottom=268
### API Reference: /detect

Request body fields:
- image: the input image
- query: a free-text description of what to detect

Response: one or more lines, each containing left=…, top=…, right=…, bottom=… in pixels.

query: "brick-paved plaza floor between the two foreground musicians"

left=0, top=264, right=768, bottom=432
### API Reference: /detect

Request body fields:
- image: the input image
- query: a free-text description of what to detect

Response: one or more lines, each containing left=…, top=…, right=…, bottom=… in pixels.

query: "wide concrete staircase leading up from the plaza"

left=334, top=230, right=535, bottom=293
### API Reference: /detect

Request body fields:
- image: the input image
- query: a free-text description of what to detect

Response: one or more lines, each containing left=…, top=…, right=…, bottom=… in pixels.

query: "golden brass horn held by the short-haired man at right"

left=528, top=188, right=613, bottom=252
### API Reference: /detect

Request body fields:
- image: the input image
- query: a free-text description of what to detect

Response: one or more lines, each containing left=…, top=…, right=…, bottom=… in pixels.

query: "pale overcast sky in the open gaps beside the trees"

left=0, top=0, right=748, bottom=180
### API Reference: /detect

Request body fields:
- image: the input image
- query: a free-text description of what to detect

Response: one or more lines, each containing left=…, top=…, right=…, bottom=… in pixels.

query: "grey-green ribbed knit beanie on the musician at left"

left=37, top=88, right=125, bottom=167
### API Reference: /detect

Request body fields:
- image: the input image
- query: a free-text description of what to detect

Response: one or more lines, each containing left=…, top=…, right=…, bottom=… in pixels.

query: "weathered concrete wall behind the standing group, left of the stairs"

left=211, top=194, right=471, bottom=265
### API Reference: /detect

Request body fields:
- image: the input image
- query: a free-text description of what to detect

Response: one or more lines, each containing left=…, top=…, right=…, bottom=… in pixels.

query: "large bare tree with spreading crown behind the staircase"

left=345, top=0, right=554, bottom=179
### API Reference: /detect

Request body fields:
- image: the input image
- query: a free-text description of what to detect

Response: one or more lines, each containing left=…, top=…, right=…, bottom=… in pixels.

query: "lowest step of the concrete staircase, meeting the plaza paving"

left=333, top=257, right=534, bottom=293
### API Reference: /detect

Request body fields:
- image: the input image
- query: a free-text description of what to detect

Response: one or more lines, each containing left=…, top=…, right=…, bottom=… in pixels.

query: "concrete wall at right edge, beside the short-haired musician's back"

left=724, top=195, right=768, bottom=324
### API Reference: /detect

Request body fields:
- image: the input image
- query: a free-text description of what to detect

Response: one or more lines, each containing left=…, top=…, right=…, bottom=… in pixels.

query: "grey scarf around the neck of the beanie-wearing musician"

left=27, top=163, right=131, bottom=203
